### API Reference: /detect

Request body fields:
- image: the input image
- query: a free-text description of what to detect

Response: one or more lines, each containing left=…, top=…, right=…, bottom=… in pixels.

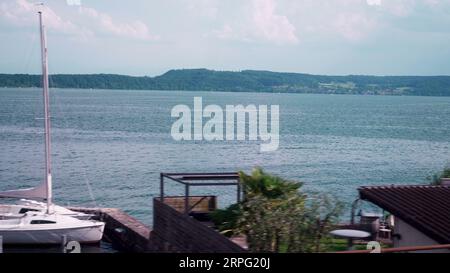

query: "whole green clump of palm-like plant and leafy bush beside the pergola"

left=213, top=168, right=342, bottom=252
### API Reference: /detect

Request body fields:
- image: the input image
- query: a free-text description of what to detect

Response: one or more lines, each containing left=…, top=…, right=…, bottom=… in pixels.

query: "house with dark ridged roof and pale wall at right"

left=358, top=185, right=450, bottom=253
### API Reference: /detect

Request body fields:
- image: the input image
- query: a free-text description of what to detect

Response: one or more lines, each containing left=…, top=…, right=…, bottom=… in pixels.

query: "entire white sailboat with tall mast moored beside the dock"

left=0, top=8, right=105, bottom=244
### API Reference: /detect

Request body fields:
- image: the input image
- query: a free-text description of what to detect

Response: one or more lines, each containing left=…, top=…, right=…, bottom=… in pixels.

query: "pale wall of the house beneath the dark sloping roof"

left=393, top=217, right=450, bottom=253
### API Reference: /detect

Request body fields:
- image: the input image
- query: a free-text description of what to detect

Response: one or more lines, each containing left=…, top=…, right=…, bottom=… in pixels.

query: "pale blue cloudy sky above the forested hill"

left=0, top=0, right=450, bottom=76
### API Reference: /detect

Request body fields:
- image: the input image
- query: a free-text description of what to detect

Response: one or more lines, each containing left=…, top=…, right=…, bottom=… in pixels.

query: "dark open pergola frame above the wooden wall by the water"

left=160, top=172, right=242, bottom=214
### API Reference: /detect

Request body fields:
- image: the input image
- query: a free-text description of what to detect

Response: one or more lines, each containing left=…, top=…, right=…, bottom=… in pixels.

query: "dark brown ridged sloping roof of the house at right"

left=358, top=186, right=450, bottom=244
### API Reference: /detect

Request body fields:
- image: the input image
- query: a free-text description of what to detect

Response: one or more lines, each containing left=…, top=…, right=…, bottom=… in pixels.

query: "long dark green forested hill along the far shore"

left=0, top=69, right=450, bottom=96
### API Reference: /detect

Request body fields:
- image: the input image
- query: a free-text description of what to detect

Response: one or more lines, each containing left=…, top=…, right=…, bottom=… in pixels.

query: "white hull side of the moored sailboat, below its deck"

left=0, top=223, right=105, bottom=244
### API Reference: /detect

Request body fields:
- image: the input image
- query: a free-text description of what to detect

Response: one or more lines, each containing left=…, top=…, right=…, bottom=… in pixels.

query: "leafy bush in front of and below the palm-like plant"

left=238, top=190, right=341, bottom=253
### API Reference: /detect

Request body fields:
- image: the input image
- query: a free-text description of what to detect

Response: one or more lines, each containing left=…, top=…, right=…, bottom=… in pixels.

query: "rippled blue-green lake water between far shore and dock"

left=0, top=89, right=450, bottom=224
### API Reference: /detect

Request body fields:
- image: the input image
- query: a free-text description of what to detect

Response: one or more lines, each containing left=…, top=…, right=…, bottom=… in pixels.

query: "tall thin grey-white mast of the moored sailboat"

left=39, top=11, right=52, bottom=213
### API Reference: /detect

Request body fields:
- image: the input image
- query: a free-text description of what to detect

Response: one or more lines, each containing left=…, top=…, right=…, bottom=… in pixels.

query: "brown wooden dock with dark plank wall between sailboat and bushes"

left=69, top=196, right=247, bottom=253
